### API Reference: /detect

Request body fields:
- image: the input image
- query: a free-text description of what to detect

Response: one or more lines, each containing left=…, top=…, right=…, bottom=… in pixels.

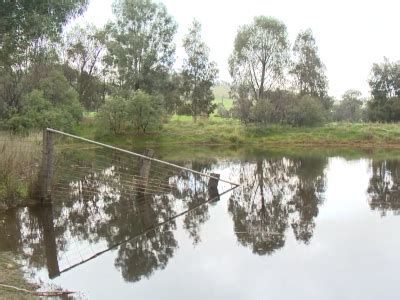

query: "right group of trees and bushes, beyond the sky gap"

left=225, top=16, right=400, bottom=126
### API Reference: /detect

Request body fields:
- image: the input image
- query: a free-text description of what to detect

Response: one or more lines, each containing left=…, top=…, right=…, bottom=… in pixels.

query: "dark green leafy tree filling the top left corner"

left=0, top=0, right=89, bottom=118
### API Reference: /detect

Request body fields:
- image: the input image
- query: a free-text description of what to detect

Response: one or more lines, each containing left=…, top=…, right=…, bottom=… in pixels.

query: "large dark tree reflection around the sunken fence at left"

left=0, top=149, right=222, bottom=282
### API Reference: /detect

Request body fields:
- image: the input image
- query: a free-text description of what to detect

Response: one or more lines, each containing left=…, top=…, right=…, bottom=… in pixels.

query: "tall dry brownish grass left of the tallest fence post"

left=0, top=132, right=41, bottom=208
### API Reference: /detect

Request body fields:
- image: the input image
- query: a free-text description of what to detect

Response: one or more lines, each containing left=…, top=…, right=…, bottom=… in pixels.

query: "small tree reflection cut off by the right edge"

left=368, top=160, right=400, bottom=216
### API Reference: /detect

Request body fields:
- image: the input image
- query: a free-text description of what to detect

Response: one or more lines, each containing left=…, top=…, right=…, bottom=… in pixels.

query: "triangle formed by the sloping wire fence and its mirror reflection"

left=38, top=129, right=238, bottom=277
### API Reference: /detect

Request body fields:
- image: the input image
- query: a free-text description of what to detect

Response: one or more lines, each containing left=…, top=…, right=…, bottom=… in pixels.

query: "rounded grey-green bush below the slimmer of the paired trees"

left=287, top=96, right=326, bottom=126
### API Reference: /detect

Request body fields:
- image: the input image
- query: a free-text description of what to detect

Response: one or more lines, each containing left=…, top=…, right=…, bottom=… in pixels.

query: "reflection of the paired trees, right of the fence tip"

left=229, top=157, right=327, bottom=255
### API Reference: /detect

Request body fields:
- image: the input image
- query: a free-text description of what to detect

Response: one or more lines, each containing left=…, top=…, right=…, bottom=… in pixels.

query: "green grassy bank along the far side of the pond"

left=76, top=116, right=400, bottom=148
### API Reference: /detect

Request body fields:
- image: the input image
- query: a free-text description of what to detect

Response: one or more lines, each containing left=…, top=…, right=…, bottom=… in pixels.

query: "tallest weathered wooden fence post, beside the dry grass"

left=40, top=129, right=54, bottom=202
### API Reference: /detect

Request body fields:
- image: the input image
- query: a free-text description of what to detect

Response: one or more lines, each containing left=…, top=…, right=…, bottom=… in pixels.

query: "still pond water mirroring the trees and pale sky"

left=0, top=150, right=400, bottom=299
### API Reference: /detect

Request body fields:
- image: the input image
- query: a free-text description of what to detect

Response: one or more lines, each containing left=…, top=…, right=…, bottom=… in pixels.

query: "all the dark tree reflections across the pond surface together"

left=0, top=152, right=400, bottom=290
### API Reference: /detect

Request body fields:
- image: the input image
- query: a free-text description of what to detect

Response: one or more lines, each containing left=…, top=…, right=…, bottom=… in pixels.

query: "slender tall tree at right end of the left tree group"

left=182, top=20, right=218, bottom=120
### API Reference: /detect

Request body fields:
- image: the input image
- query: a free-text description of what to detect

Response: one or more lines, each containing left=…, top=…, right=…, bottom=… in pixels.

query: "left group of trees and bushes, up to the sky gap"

left=0, top=0, right=218, bottom=133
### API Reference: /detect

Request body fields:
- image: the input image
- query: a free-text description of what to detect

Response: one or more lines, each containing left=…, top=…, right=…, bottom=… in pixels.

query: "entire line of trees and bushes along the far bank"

left=0, top=0, right=400, bottom=134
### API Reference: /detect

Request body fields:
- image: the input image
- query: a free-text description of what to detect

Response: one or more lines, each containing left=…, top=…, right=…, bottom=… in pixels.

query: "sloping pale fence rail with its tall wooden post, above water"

left=40, top=128, right=239, bottom=202
